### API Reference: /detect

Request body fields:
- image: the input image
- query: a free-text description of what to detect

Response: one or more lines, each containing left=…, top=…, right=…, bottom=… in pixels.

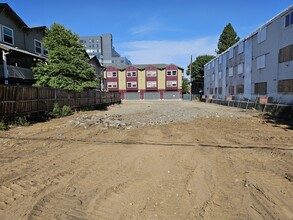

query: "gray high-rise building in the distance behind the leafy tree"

left=80, top=34, right=131, bottom=66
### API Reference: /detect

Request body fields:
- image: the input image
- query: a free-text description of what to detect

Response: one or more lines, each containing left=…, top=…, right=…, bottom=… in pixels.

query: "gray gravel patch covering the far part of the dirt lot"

left=70, top=101, right=250, bottom=129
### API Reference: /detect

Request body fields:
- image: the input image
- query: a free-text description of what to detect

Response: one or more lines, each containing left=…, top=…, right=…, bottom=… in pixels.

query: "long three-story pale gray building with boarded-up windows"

left=204, top=5, right=293, bottom=104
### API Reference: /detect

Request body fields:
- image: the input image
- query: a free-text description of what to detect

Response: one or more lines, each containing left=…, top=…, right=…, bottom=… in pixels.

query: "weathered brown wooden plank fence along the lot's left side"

left=0, top=85, right=121, bottom=118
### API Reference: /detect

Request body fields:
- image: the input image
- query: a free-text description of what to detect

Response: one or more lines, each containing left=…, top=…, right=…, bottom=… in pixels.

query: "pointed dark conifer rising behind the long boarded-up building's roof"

left=216, top=23, right=239, bottom=54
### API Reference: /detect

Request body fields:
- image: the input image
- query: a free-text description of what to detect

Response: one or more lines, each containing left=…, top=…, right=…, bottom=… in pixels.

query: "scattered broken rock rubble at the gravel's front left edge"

left=69, top=114, right=132, bottom=129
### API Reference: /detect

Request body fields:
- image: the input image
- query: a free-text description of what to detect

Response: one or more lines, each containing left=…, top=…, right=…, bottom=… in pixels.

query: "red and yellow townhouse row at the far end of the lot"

left=104, top=64, right=184, bottom=100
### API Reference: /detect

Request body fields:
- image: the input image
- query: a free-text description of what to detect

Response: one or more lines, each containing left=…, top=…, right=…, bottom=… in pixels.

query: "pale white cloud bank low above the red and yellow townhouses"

left=119, top=37, right=218, bottom=72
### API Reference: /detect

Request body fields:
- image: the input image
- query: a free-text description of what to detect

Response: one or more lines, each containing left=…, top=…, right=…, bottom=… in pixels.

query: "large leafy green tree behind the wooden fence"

left=32, top=23, right=97, bottom=91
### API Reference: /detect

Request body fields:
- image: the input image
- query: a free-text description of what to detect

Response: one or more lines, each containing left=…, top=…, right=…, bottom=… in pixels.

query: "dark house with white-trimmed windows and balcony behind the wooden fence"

left=0, top=3, right=47, bottom=85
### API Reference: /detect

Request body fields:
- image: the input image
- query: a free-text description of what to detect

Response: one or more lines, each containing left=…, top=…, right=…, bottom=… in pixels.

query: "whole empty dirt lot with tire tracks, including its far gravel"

left=0, top=101, right=293, bottom=220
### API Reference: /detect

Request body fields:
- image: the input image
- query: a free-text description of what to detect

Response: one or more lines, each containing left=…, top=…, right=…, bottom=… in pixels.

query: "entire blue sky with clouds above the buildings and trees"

left=2, top=0, right=293, bottom=72
